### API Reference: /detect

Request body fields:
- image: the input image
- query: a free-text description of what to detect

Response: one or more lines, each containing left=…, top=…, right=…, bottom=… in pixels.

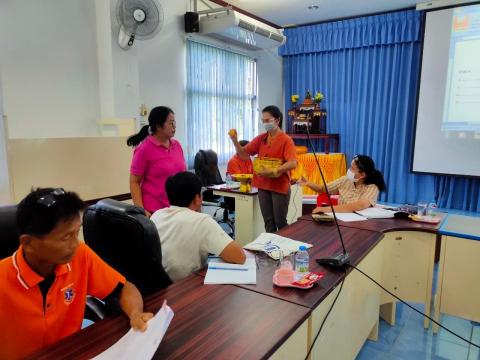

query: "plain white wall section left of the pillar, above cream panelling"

left=0, top=0, right=99, bottom=138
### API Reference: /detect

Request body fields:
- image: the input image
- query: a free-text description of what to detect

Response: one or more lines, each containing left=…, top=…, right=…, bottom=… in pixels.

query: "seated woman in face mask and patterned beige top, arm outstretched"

left=298, top=155, right=386, bottom=214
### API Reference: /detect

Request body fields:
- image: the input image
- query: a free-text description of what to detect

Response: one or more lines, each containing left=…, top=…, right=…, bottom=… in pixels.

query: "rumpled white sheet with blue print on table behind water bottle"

left=243, top=233, right=312, bottom=260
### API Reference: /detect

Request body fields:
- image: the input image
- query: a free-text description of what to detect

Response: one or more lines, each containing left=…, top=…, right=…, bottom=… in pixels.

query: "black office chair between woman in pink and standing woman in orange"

left=194, top=150, right=235, bottom=237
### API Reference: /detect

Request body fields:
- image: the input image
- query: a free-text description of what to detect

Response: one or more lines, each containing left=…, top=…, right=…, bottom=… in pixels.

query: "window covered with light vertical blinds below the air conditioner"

left=187, top=40, right=258, bottom=168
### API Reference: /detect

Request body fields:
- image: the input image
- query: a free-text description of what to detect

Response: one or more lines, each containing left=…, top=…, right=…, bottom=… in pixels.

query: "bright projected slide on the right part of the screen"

left=442, top=6, right=480, bottom=137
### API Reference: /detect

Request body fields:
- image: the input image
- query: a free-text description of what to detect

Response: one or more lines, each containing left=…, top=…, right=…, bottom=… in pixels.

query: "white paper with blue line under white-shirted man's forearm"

left=203, top=258, right=257, bottom=284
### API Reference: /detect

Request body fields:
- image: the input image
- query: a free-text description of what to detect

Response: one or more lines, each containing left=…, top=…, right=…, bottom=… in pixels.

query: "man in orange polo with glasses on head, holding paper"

left=0, top=188, right=153, bottom=359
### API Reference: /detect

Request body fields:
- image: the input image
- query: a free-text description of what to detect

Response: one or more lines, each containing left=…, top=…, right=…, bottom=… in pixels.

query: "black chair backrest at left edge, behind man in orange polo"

left=0, top=205, right=19, bottom=259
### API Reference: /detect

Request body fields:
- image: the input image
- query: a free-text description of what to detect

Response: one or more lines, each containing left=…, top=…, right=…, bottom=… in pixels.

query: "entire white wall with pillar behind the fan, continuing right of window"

left=0, top=0, right=283, bottom=147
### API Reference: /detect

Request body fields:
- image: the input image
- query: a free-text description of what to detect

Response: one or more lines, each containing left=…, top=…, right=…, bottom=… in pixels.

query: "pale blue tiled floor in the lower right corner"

left=357, top=303, right=480, bottom=360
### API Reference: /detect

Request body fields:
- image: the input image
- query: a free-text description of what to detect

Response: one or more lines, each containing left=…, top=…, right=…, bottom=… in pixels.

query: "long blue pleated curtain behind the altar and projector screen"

left=280, top=10, right=480, bottom=211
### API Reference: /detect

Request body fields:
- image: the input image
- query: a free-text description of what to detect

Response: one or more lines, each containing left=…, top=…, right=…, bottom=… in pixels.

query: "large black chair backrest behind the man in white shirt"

left=83, top=199, right=171, bottom=296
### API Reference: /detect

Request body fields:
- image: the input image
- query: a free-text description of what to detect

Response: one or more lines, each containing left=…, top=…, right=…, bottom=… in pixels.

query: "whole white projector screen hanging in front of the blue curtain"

left=412, top=5, right=480, bottom=176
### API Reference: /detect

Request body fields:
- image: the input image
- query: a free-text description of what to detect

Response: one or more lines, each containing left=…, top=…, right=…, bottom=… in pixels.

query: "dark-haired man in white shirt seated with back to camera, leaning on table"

left=150, top=171, right=246, bottom=282
